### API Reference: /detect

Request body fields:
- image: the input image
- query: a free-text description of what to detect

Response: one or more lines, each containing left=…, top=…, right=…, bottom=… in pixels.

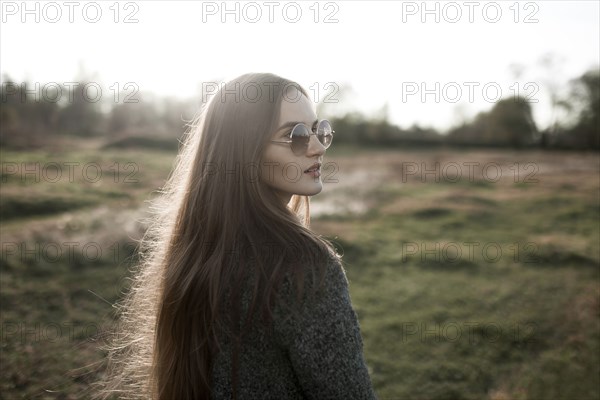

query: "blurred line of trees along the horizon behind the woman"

left=0, top=69, right=600, bottom=150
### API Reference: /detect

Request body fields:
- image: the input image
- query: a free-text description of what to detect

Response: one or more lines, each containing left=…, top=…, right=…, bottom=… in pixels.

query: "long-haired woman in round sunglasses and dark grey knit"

left=100, top=74, right=375, bottom=400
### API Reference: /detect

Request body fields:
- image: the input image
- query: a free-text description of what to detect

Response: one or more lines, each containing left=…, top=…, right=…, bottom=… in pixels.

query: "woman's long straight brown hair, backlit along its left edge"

left=101, top=73, right=337, bottom=400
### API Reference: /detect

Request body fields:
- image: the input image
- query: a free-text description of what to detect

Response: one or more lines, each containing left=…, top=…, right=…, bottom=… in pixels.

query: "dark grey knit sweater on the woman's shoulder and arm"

left=212, top=260, right=376, bottom=400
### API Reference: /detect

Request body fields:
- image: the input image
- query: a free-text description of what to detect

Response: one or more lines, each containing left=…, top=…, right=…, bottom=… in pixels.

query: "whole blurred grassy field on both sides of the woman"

left=0, top=147, right=600, bottom=400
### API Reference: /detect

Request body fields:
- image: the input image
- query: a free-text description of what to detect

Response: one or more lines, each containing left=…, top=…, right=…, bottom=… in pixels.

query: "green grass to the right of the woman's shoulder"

left=315, top=148, right=600, bottom=400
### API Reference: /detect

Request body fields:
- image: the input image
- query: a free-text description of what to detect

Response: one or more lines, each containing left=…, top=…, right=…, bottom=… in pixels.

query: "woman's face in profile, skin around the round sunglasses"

left=260, top=93, right=325, bottom=204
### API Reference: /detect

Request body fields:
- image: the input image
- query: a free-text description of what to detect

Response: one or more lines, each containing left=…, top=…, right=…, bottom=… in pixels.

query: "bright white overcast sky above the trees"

left=0, top=0, right=600, bottom=131
